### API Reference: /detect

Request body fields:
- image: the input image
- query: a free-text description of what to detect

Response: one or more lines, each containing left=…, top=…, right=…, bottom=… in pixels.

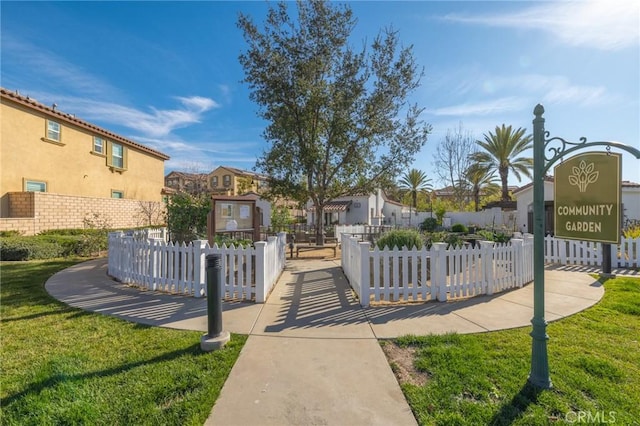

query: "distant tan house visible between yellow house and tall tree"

left=207, top=166, right=267, bottom=195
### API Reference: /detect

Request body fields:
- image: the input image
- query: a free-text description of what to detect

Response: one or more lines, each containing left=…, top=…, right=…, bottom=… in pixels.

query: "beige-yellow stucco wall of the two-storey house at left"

left=0, top=98, right=164, bottom=217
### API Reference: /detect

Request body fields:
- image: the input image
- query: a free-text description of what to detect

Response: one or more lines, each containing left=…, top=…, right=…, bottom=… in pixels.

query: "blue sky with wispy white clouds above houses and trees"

left=0, top=0, right=640, bottom=186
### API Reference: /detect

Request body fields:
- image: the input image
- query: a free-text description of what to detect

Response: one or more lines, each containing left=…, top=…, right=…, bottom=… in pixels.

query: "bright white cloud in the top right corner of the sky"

left=444, top=0, right=640, bottom=50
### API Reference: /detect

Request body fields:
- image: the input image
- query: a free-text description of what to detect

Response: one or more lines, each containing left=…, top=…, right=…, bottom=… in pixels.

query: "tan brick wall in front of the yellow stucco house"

left=0, top=192, right=165, bottom=235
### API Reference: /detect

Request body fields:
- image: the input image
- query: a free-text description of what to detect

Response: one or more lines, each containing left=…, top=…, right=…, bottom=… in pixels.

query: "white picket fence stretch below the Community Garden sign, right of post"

left=544, top=236, right=640, bottom=268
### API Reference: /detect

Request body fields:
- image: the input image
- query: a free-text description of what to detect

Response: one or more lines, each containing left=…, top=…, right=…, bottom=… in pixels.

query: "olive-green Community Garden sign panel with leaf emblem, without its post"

left=553, top=152, right=622, bottom=244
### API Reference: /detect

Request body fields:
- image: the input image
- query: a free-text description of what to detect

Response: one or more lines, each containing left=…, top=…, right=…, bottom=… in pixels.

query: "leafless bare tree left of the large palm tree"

left=433, top=122, right=477, bottom=209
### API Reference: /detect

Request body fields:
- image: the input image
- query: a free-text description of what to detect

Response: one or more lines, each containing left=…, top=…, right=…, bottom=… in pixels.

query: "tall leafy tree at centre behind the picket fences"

left=238, top=0, right=431, bottom=244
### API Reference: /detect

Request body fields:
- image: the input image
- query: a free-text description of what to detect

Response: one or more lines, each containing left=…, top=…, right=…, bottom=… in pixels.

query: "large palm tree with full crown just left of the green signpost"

left=470, top=124, right=533, bottom=201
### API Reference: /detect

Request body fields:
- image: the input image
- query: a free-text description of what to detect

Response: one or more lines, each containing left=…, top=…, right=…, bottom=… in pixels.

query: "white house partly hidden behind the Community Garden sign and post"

left=513, top=176, right=640, bottom=234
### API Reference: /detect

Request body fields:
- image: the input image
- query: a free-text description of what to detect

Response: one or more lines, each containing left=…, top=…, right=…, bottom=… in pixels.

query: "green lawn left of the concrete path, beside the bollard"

left=0, top=260, right=246, bottom=425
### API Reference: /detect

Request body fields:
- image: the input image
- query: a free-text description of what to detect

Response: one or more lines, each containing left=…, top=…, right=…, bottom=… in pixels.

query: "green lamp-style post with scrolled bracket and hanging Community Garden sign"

left=529, top=104, right=640, bottom=389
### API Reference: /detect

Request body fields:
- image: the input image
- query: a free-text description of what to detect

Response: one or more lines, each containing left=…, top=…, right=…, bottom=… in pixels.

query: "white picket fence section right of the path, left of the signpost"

left=341, top=234, right=533, bottom=306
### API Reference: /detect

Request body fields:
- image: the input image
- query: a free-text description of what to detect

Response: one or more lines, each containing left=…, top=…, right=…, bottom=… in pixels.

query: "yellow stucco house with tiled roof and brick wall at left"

left=0, top=88, right=169, bottom=234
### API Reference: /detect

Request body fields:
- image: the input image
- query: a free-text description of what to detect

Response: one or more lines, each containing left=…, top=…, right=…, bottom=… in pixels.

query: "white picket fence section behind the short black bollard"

left=108, top=232, right=286, bottom=303
